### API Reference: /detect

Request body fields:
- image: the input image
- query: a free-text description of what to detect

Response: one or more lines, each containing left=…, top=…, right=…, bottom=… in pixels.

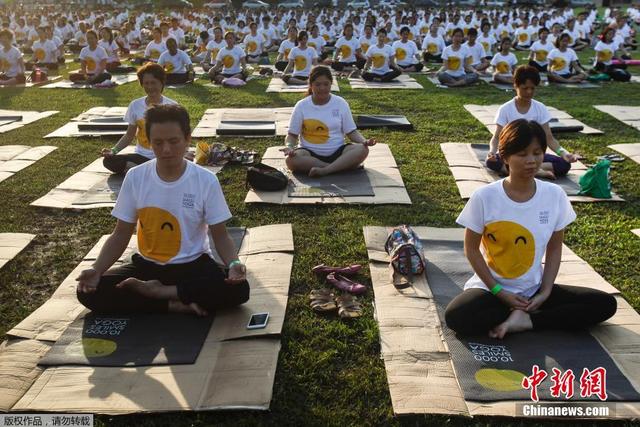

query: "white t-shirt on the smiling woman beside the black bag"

left=289, top=94, right=358, bottom=156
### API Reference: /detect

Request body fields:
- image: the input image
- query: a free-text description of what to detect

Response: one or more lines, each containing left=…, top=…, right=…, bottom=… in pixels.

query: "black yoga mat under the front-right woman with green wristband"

left=420, top=230, right=640, bottom=402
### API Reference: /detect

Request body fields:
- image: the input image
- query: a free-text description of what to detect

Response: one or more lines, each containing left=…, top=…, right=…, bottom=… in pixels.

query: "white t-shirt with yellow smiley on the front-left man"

left=111, top=160, right=231, bottom=265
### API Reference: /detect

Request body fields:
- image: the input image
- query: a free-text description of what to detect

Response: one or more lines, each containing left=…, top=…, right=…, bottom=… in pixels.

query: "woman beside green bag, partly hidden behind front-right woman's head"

left=486, top=65, right=578, bottom=179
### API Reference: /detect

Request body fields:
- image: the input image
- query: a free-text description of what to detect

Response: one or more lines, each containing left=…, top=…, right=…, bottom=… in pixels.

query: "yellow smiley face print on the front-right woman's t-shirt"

left=482, top=221, right=536, bottom=279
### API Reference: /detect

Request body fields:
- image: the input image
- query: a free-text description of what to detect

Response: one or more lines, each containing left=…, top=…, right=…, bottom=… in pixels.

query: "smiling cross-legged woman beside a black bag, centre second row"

left=282, top=65, right=376, bottom=176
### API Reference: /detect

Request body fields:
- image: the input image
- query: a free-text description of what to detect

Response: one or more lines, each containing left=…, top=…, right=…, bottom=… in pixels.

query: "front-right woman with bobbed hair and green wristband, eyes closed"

left=445, top=119, right=616, bottom=339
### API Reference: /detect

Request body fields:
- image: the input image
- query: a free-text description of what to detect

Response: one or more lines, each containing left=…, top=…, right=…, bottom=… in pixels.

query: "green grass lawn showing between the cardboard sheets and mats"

left=0, top=45, right=640, bottom=426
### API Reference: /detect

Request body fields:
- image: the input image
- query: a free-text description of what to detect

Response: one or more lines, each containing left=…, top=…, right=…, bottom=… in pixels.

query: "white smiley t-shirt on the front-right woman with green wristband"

left=456, top=179, right=576, bottom=298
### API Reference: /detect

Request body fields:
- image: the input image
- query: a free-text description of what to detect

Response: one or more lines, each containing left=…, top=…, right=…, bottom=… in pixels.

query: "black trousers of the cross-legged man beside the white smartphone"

left=77, top=254, right=249, bottom=313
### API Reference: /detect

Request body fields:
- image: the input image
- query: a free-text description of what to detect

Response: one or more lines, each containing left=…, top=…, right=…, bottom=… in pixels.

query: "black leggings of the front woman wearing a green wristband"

left=444, top=285, right=617, bottom=335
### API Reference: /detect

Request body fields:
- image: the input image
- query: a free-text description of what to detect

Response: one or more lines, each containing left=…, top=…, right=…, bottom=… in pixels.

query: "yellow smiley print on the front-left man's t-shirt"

left=138, top=206, right=182, bottom=262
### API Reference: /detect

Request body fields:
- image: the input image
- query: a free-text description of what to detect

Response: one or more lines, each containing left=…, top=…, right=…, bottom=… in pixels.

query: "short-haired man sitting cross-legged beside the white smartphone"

left=76, top=105, right=249, bottom=316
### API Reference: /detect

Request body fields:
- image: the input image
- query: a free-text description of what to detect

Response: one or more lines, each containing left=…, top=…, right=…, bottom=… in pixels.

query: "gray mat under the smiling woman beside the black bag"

left=288, top=168, right=375, bottom=197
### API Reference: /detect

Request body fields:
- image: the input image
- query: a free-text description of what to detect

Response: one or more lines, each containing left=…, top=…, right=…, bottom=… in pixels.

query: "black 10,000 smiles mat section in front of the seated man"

left=39, top=313, right=213, bottom=368
